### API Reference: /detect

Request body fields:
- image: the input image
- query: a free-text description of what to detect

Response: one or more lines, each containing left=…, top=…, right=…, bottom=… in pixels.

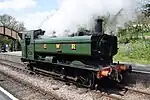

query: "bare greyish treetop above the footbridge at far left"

left=0, top=14, right=26, bottom=32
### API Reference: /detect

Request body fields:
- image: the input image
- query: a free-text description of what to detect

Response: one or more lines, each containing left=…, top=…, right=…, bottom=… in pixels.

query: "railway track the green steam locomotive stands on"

left=0, top=59, right=150, bottom=100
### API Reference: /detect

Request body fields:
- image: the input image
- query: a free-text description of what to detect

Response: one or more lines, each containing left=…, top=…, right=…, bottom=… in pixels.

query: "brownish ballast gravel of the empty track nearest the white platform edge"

left=0, top=73, right=57, bottom=100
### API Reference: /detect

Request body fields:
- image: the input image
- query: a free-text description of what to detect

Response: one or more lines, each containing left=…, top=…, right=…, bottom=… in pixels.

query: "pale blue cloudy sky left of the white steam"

left=0, top=0, right=59, bottom=29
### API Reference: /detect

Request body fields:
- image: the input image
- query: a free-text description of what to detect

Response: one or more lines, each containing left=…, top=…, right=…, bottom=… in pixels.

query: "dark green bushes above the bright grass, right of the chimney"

left=117, top=14, right=150, bottom=43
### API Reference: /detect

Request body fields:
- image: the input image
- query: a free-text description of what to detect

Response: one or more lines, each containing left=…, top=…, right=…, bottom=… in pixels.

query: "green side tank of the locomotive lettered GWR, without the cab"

left=35, top=36, right=91, bottom=55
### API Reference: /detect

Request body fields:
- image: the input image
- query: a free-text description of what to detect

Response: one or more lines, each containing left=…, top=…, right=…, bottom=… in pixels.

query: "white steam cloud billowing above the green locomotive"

left=42, top=0, right=138, bottom=36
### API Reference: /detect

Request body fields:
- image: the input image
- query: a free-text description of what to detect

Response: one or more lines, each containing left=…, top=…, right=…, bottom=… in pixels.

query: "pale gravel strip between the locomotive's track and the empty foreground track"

left=0, top=66, right=111, bottom=100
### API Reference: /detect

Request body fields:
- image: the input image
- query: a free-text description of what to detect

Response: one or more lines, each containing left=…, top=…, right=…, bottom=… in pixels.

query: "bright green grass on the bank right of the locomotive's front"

left=114, top=32, right=150, bottom=64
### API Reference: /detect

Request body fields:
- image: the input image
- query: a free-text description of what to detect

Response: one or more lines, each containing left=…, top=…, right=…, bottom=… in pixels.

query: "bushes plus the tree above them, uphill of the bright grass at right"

left=117, top=1, right=150, bottom=43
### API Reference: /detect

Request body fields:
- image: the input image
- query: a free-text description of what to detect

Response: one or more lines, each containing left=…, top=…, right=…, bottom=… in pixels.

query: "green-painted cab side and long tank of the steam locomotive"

left=21, top=31, right=92, bottom=60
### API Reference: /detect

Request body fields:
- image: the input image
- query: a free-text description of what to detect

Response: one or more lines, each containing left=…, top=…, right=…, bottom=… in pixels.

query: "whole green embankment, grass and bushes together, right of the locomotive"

left=114, top=3, right=150, bottom=64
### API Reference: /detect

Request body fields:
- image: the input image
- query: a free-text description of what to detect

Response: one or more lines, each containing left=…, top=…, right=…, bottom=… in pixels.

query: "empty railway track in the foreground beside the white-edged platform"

left=0, top=72, right=59, bottom=100
